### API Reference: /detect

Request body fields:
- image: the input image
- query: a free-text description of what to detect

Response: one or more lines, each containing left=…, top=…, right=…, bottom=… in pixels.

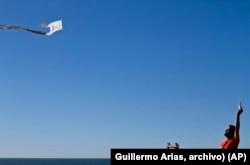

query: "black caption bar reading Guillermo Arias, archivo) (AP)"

left=111, top=149, right=250, bottom=165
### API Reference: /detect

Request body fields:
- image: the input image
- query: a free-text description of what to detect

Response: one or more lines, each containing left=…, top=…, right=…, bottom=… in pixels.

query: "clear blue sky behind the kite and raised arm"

left=0, top=0, right=250, bottom=158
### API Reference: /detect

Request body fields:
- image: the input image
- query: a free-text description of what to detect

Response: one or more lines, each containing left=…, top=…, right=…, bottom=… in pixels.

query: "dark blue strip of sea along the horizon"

left=0, top=158, right=110, bottom=165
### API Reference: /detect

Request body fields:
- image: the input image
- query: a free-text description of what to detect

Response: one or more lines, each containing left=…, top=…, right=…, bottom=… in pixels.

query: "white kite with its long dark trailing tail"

left=0, top=20, right=63, bottom=36
